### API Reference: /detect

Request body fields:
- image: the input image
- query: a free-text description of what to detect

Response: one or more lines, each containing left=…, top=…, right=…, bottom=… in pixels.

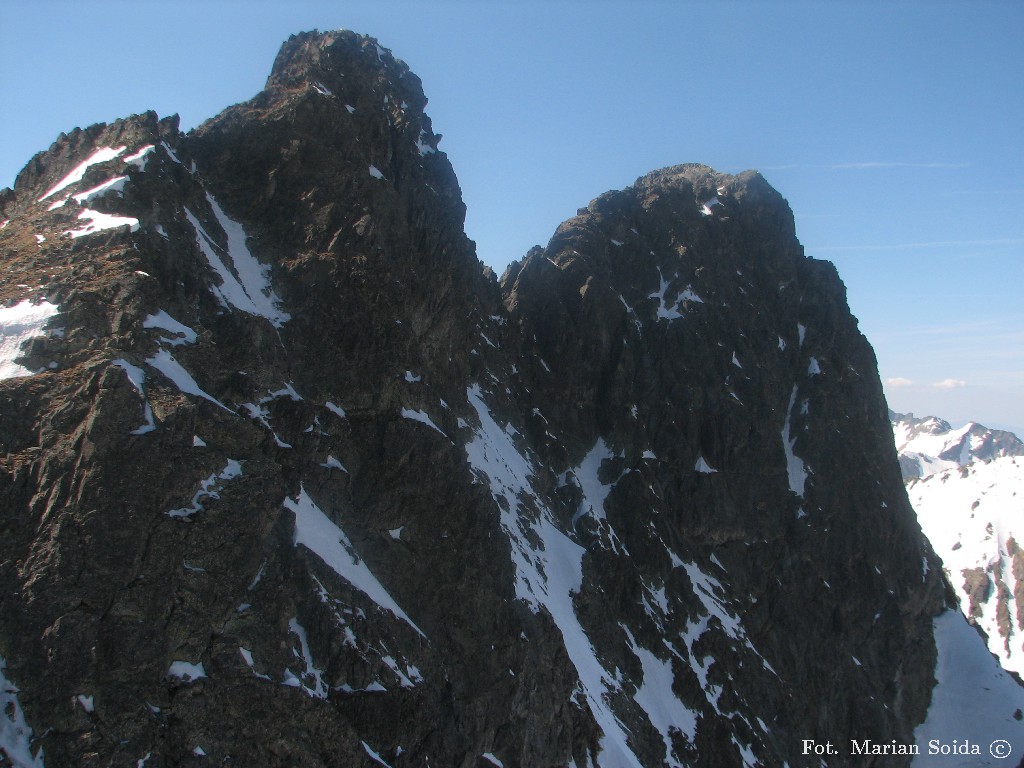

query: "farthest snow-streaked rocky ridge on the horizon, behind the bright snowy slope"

left=889, top=410, right=1024, bottom=479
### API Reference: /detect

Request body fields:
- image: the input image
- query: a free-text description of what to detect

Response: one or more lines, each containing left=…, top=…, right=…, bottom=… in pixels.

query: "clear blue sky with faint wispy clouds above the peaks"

left=0, top=0, right=1024, bottom=436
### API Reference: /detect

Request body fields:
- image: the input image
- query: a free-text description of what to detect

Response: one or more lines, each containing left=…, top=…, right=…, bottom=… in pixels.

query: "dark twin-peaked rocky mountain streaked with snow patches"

left=0, top=32, right=948, bottom=767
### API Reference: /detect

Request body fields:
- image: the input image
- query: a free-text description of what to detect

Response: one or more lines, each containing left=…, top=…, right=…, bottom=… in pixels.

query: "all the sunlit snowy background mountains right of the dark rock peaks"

left=889, top=411, right=1024, bottom=675
